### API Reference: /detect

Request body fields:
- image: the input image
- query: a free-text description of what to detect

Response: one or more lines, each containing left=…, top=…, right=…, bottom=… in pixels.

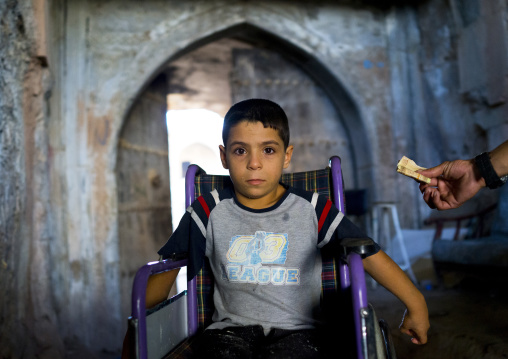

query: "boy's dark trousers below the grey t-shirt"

left=192, top=325, right=322, bottom=359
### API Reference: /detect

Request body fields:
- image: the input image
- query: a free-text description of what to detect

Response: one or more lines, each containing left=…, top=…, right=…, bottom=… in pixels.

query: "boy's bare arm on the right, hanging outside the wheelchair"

left=363, top=250, right=430, bottom=344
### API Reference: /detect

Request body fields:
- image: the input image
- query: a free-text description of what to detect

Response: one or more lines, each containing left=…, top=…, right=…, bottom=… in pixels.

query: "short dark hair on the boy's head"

left=222, top=98, right=289, bottom=150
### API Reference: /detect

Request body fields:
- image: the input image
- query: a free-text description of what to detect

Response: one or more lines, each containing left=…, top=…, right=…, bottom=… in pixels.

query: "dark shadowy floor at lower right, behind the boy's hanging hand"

left=368, top=284, right=508, bottom=359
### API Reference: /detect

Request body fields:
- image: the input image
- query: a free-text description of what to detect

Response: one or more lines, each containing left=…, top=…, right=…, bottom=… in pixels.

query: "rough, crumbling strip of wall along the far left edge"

left=0, top=1, right=64, bottom=358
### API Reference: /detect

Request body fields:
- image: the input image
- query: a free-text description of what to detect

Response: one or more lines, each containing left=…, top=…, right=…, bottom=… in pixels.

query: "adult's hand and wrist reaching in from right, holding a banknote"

left=418, top=141, right=508, bottom=210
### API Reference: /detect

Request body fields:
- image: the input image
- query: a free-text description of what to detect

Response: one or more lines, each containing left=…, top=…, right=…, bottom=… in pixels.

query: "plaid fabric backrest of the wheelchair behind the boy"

left=194, top=167, right=337, bottom=328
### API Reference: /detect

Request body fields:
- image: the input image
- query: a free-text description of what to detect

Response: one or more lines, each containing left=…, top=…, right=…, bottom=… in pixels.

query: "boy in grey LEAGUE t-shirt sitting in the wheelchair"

left=159, top=99, right=429, bottom=358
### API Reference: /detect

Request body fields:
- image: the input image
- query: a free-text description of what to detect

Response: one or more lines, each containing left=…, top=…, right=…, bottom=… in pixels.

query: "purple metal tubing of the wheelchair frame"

left=132, top=156, right=368, bottom=359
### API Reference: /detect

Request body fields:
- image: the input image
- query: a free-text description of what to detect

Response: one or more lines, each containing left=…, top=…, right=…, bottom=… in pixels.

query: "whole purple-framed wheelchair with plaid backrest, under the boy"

left=128, top=156, right=396, bottom=359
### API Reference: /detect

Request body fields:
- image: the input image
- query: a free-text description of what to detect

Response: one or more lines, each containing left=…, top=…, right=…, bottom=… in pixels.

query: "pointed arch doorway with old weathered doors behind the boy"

left=116, top=24, right=372, bottom=338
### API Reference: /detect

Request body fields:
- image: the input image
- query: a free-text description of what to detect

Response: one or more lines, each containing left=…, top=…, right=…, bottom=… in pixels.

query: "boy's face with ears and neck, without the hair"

left=219, top=121, right=293, bottom=209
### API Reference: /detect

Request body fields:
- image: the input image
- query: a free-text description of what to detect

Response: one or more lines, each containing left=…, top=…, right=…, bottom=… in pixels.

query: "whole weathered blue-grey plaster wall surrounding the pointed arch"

left=0, top=0, right=508, bottom=358
